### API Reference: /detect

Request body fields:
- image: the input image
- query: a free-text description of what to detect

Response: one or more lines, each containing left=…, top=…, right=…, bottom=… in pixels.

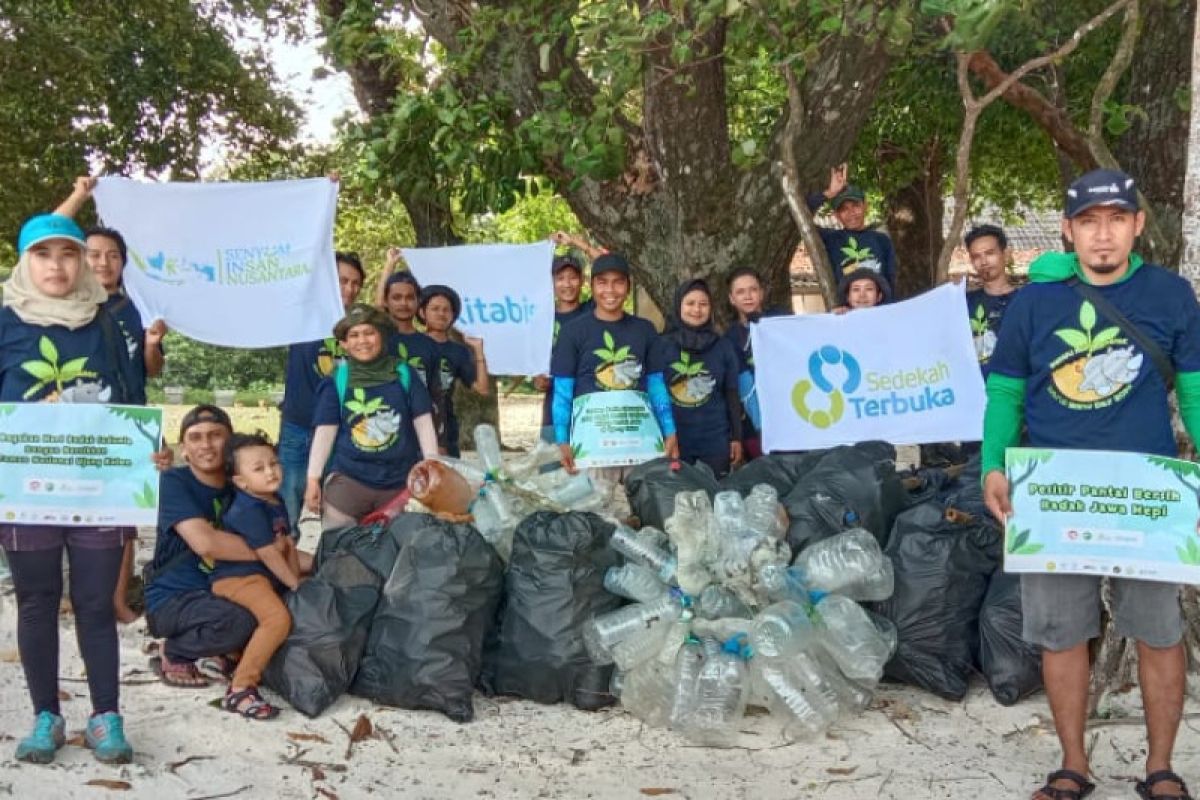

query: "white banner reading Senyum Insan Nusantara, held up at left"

left=95, top=178, right=343, bottom=348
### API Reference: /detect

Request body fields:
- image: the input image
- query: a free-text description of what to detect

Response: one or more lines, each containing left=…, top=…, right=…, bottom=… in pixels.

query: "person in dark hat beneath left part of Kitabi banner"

left=420, top=284, right=488, bottom=458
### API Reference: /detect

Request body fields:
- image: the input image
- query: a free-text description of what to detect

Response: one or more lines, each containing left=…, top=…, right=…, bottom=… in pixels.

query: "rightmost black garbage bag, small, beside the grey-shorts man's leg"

left=979, top=570, right=1042, bottom=705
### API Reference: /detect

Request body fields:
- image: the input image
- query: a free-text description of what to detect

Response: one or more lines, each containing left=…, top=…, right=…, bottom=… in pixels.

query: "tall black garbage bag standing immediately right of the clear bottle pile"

left=875, top=503, right=1001, bottom=700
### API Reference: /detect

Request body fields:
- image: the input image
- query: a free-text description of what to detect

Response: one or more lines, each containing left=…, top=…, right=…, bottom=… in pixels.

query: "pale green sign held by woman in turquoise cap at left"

left=0, top=403, right=162, bottom=525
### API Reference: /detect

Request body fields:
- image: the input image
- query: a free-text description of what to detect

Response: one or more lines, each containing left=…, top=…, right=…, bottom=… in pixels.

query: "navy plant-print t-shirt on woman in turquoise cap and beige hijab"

left=0, top=307, right=133, bottom=403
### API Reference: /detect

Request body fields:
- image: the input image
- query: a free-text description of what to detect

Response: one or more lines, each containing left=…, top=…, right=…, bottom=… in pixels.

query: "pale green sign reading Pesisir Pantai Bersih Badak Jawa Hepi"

left=1004, top=447, right=1200, bottom=584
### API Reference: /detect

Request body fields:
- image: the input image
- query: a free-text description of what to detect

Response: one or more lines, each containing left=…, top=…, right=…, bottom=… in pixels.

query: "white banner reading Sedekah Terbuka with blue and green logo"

left=750, top=284, right=985, bottom=451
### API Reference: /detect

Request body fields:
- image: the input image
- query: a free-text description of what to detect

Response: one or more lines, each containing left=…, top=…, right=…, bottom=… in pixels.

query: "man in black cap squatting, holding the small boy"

left=145, top=405, right=258, bottom=686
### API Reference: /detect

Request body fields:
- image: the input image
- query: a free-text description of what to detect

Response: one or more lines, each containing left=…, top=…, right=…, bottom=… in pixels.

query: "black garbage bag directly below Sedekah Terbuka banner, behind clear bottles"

left=782, top=443, right=907, bottom=553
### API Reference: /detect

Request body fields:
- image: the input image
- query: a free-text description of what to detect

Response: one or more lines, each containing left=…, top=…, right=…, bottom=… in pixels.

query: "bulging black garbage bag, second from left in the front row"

left=350, top=513, right=504, bottom=722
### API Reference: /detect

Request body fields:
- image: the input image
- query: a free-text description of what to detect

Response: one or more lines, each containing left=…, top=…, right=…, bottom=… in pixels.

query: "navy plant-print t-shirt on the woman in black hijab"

left=659, top=335, right=739, bottom=458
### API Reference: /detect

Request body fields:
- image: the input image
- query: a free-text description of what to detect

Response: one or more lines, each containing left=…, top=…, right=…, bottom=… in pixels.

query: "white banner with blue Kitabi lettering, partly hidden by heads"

left=404, top=241, right=554, bottom=375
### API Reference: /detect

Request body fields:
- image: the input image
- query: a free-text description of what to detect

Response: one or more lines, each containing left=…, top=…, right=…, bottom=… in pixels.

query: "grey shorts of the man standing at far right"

left=1021, top=573, right=1183, bottom=651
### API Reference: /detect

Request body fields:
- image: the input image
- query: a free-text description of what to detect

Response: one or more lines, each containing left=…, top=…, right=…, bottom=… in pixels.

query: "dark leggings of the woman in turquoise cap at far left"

left=6, top=543, right=124, bottom=714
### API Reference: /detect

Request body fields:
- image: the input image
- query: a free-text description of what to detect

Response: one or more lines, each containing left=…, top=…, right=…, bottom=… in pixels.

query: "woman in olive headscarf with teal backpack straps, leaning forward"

left=305, top=303, right=438, bottom=530
